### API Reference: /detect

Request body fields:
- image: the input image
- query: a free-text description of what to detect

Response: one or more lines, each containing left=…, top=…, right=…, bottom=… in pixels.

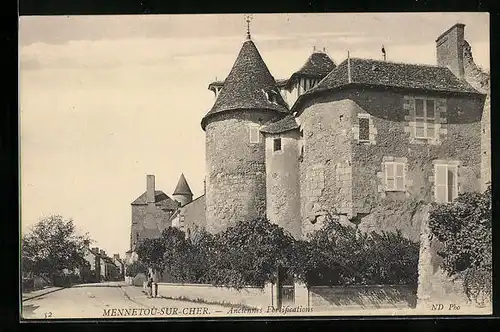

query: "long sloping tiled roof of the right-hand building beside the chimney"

left=294, top=58, right=480, bottom=109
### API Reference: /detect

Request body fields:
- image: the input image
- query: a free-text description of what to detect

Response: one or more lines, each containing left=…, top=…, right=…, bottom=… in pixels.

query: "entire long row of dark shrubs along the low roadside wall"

left=129, top=219, right=419, bottom=288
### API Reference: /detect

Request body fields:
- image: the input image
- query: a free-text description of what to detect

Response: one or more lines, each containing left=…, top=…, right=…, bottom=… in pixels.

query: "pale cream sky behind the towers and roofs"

left=19, top=13, right=490, bottom=255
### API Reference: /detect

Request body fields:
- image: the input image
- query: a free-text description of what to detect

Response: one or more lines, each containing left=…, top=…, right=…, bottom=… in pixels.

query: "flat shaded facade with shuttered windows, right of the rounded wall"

left=350, top=91, right=481, bottom=241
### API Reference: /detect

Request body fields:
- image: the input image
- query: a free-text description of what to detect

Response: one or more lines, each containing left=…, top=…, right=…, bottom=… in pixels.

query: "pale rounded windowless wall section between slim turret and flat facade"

left=299, top=97, right=356, bottom=236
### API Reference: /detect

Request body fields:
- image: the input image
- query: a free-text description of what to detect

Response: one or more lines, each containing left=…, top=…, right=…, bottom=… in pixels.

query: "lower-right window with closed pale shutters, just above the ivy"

left=434, top=164, right=458, bottom=203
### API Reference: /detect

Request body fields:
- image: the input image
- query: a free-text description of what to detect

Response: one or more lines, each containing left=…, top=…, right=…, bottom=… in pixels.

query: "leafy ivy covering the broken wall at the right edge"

left=429, top=186, right=492, bottom=304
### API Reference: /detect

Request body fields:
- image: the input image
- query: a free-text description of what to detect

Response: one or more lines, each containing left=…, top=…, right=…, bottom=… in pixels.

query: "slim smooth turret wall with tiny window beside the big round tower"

left=266, top=130, right=301, bottom=238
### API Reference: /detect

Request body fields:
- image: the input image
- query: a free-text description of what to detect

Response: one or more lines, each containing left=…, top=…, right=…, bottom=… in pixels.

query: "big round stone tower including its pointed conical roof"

left=201, top=34, right=289, bottom=233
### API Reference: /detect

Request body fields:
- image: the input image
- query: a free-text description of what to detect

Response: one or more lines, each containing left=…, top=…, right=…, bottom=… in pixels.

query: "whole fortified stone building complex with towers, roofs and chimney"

left=131, top=24, right=490, bottom=243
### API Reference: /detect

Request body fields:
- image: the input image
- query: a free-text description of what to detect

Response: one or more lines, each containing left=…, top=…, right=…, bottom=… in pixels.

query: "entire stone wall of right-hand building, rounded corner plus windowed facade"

left=299, top=90, right=482, bottom=241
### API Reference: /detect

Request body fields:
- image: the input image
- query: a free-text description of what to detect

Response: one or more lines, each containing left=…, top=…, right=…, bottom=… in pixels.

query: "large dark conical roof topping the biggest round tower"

left=201, top=39, right=289, bottom=129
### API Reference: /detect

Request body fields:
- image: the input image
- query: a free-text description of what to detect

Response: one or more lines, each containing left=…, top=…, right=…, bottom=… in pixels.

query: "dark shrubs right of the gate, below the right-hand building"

left=296, top=217, right=419, bottom=286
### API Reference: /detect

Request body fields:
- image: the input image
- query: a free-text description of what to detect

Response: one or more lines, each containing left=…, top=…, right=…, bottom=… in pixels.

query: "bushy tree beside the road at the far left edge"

left=21, top=215, right=90, bottom=282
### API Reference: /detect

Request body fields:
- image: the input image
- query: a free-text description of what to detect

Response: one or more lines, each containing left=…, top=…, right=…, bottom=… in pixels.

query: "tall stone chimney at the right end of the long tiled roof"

left=436, top=23, right=465, bottom=78
